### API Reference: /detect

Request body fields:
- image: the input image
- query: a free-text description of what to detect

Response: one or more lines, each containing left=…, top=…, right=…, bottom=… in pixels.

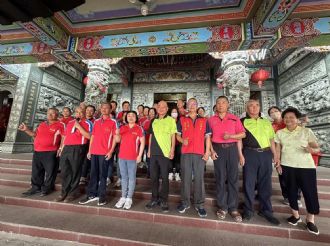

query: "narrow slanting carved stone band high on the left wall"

left=42, top=73, right=82, bottom=100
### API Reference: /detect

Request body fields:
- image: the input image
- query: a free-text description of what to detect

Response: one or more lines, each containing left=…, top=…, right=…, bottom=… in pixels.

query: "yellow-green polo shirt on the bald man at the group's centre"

left=150, top=116, right=177, bottom=157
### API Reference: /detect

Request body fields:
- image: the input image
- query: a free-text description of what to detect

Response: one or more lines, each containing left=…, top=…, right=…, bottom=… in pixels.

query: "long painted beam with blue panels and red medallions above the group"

left=0, top=17, right=330, bottom=63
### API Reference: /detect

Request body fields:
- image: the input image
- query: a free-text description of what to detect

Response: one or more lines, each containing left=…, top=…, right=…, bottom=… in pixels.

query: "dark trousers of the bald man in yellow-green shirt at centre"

left=150, top=155, right=171, bottom=202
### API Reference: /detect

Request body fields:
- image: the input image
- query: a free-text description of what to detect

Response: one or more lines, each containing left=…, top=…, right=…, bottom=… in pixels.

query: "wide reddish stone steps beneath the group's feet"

left=0, top=158, right=330, bottom=246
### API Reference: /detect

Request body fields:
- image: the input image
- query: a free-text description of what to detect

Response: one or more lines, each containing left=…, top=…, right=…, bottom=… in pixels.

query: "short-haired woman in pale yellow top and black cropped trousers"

left=275, top=108, right=320, bottom=235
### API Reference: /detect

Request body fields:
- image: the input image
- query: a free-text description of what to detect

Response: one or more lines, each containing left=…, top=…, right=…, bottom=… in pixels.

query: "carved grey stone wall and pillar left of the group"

left=0, top=64, right=83, bottom=153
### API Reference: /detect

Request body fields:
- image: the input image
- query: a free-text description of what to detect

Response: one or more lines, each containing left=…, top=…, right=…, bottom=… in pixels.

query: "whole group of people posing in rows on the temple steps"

left=19, top=96, right=319, bottom=234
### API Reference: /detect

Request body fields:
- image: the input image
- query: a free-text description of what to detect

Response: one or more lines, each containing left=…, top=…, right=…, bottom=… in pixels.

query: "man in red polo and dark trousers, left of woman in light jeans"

left=79, top=103, right=118, bottom=206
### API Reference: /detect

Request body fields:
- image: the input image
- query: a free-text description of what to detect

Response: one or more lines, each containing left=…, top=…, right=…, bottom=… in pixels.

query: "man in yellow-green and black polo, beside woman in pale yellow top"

left=241, top=100, right=280, bottom=225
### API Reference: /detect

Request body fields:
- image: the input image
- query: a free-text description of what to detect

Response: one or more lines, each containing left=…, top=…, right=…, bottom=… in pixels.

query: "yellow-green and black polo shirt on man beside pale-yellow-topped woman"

left=241, top=116, right=275, bottom=148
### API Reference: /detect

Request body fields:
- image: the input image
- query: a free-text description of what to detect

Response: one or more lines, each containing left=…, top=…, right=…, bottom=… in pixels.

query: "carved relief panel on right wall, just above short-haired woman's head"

left=281, top=78, right=330, bottom=113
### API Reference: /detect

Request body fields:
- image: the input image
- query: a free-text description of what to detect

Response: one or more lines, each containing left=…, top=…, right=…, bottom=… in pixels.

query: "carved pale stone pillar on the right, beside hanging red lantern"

left=221, top=52, right=250, bottom=116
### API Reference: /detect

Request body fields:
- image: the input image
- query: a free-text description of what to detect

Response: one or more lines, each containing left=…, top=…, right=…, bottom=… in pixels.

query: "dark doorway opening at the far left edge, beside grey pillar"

left=0, top=91, right=13, bottom=142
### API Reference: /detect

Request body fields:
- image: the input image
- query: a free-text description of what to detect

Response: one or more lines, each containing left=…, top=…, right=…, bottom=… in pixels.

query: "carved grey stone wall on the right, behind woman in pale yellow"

left=278, top=50, right=330, bottom=166
